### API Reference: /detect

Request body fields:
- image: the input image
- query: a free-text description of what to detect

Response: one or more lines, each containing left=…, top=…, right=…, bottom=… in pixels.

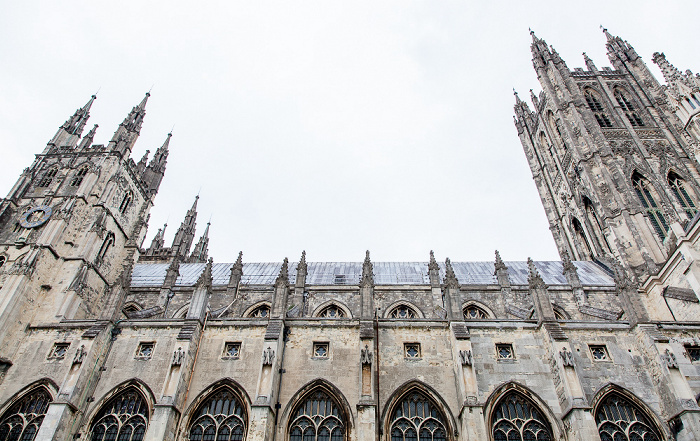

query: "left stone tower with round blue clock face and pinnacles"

left=0, top=94, right=170, bottom=359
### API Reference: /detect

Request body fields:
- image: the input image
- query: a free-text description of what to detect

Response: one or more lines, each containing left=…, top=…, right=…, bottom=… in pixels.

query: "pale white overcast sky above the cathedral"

left=0, top=0, right=700, bottom=262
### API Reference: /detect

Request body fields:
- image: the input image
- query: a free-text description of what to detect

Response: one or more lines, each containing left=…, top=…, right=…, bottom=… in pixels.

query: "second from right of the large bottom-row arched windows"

left=491, top=392, right=554, bottom=441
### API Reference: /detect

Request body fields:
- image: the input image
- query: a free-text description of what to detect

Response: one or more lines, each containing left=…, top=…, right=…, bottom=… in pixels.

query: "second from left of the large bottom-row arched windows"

left=90, top=386, right=149, bottom=441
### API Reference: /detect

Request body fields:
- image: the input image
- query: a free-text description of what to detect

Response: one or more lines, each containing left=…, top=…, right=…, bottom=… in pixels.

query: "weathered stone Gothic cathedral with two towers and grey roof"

left=0, top=30, right=700, bottom=441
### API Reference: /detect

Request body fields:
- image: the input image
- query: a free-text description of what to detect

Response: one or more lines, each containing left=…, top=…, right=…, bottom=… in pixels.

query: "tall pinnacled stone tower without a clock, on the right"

left=515, top=30, right=700, bottom=276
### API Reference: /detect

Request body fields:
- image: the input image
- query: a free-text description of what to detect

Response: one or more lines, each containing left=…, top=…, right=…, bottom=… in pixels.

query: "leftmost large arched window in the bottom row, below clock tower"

left=0, top=387, right=52, bottom=441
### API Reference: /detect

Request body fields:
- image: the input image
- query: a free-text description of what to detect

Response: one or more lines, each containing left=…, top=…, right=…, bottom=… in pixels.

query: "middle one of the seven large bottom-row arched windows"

left=288, top=390, right=347, bottom=441
